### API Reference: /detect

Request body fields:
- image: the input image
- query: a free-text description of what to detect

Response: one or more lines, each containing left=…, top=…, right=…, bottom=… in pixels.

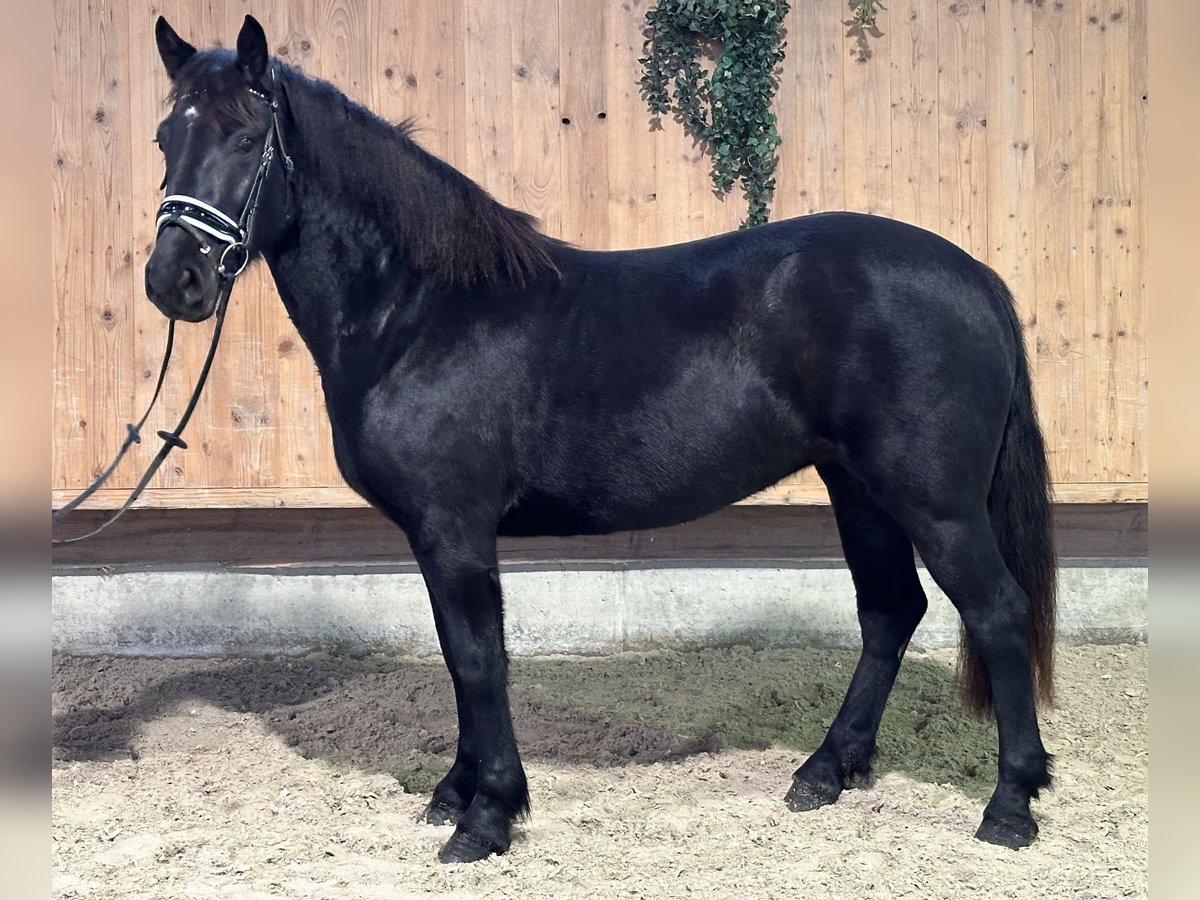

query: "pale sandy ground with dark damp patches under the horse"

left=53, top=646, right=1148, bottom=900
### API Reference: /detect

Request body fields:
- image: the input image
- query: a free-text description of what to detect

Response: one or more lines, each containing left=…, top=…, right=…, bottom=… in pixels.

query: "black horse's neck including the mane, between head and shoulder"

left=266, top=85, right=544, bottom=384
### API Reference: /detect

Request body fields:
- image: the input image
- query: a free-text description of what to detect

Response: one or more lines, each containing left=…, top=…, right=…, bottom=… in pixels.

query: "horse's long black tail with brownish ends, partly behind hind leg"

left=959, top=270, right=1057, bottom=715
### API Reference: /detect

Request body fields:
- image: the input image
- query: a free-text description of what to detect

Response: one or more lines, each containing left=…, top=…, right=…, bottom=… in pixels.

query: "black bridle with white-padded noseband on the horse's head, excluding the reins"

left=156, top=80, right=293, bottom=280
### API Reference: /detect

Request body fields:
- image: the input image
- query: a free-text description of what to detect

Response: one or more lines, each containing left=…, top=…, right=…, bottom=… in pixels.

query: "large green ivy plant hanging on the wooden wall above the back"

left=641, top=0, right=788, bottom=228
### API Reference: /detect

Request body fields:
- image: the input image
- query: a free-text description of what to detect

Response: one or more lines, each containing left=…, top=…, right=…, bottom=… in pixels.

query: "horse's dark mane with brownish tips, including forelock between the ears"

left=170, top=50, right=558, bottom=284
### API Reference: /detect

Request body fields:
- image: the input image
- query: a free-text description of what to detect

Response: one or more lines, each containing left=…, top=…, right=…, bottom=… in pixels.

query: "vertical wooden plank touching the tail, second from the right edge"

left=1030, top=4, right=1088, bottom=484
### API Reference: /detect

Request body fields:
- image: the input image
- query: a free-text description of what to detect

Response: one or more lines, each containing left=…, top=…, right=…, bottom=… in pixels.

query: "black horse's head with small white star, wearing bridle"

left=145, top=16, right=290, bottom=322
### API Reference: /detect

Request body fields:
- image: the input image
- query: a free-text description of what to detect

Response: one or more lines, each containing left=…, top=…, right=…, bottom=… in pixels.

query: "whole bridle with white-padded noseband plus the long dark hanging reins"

left=50, top=70, right=294, bottom=545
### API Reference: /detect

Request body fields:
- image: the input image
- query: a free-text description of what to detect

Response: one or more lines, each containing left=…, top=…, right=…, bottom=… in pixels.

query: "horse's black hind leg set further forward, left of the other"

left=786, top=464, right=926, bottom=811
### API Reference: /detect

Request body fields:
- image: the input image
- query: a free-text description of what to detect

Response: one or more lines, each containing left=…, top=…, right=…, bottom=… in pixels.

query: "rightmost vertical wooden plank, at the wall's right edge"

left=1081, top=0, right=1145, bottom=481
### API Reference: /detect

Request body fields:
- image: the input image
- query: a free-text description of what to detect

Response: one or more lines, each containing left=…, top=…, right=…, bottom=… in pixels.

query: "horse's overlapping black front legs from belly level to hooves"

left=414, top=533, right=529, bottom=863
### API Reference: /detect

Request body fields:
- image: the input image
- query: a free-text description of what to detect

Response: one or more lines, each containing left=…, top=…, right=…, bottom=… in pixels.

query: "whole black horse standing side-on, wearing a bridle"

left=145, top=17, right=1055, bottom=862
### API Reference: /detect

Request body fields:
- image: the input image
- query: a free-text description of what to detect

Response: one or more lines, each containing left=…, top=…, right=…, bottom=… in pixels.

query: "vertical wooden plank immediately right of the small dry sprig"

left=888, top=0, right=940, bottom=232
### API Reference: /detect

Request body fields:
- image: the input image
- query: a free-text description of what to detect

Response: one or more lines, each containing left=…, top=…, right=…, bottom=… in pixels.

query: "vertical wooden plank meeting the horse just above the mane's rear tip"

left=508, top=0, right=563, bottom=238
